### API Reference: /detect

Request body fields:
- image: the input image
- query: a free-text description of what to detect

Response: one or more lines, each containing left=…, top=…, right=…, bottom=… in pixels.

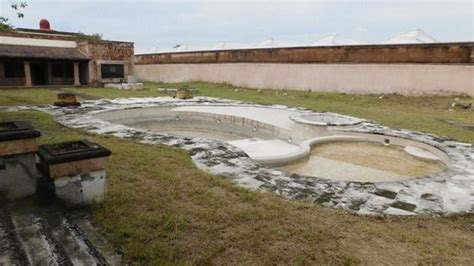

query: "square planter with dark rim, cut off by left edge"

left=0, top=121, right=41, bottom=200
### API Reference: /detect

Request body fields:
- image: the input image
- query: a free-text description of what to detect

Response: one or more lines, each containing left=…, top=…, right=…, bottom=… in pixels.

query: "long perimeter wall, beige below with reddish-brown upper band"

left=135, top=43, right=474, bottom=96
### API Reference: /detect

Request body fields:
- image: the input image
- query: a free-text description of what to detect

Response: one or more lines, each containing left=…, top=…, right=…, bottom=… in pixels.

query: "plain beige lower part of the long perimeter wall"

left=135, top=63, right=474, bottom=96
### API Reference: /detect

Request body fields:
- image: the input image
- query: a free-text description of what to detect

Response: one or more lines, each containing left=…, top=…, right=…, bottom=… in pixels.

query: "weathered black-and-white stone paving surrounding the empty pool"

left=25, top=97, right=474, bottom=215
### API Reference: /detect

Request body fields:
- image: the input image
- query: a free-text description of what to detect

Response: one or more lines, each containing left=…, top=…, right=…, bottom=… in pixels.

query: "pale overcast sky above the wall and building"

left=0, top=0, right=474, bottom=51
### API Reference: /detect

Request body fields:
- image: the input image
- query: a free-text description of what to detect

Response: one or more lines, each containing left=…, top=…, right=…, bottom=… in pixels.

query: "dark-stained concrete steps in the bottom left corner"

left=0, top=199, right=121, bottom=265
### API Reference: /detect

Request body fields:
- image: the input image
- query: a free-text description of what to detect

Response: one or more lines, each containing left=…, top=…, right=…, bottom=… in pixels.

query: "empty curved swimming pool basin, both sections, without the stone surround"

left=95, top=105, right=449, bottom=182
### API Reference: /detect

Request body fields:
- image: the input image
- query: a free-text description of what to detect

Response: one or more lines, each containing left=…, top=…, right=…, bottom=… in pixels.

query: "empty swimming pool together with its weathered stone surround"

left=46, top=97, right=474, bottom=215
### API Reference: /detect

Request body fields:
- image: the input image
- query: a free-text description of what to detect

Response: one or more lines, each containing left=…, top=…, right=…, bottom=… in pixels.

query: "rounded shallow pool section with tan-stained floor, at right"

left=278, top=141, right=445, bottom=182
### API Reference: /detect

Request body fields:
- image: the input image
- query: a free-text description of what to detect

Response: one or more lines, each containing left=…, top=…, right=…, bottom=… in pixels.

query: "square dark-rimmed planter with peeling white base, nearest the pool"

left=38, top=140, right=111, bottom=205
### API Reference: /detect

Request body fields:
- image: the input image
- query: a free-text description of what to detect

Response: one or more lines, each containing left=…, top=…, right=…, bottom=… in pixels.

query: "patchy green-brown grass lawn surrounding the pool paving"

left=0, top=83, right=474, bottom=265
